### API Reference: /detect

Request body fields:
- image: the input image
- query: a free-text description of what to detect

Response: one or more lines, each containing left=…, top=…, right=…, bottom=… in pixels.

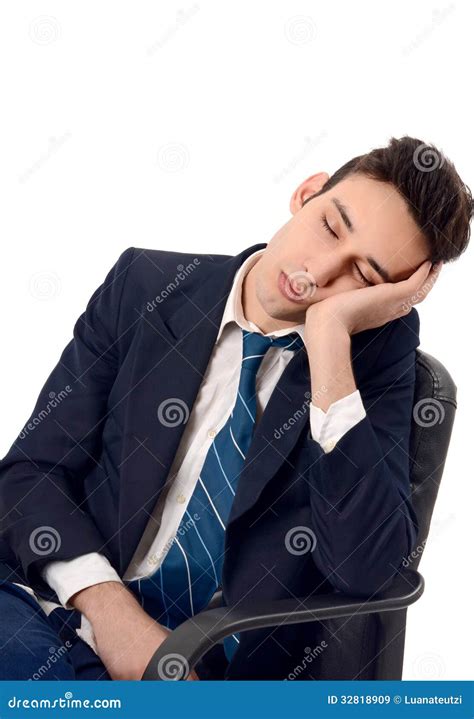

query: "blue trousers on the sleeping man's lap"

left=0, top=581, right=227, bottom=681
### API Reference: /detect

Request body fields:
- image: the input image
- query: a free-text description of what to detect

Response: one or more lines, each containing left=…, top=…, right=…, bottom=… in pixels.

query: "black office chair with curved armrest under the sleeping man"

left=142, top=350, right=457, bottom=680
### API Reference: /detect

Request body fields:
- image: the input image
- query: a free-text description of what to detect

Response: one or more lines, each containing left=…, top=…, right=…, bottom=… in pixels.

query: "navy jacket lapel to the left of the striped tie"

left=118, top=244, right=266, bottom=573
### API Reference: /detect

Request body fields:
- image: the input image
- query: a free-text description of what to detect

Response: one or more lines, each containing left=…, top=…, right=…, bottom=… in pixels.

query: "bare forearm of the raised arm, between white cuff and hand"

left=307, top=315, right=357, bottom=412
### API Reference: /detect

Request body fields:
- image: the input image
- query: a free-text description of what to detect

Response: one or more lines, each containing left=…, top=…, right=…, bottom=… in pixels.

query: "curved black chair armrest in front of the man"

left=142, top=569, right=424, bottom=681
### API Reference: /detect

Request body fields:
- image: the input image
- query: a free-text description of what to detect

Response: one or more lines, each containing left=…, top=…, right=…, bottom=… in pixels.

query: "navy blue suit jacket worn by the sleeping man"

left=0, top=243, right=419, bottom=678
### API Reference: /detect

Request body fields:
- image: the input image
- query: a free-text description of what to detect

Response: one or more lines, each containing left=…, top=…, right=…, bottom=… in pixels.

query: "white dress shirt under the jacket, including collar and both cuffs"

left=11, top=250, right=366, bottom=650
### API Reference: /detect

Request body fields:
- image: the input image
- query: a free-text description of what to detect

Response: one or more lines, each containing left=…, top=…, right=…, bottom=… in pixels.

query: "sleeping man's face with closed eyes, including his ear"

left=244, top=173, right=430, bottom=332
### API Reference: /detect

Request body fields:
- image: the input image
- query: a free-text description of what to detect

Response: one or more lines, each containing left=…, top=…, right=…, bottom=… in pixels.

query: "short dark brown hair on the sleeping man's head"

left=303, top=135, right=474, bottom=262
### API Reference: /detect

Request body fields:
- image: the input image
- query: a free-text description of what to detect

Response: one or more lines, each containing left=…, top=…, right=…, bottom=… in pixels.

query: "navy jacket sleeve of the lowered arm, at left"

left=0, top=247, right=134, bottom=587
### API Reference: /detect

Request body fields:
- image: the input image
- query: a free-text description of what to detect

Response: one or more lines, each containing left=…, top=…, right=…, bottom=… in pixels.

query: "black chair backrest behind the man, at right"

left=312, top=350, right=456, bottom=680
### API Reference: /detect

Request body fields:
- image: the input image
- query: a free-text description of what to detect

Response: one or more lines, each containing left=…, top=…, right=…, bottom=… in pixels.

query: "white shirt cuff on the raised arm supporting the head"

left=309, top=389, right=366, bottom=453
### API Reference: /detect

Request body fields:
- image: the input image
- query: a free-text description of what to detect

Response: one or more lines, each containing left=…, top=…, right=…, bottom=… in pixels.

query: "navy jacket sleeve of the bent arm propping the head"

left=308, top=309, right=419, bottom=597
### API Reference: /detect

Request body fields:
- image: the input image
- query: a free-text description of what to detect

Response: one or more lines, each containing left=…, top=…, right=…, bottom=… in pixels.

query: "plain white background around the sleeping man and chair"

left=0, top=0, right=474, bottom=679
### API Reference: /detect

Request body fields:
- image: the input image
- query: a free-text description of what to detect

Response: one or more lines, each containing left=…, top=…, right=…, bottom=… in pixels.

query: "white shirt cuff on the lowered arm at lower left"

left=40, top=552, right=123, bottom=609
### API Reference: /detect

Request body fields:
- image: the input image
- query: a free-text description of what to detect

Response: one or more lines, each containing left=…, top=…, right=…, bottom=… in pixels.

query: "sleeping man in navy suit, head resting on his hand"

left=0, top=137, right=472, bottom=679
